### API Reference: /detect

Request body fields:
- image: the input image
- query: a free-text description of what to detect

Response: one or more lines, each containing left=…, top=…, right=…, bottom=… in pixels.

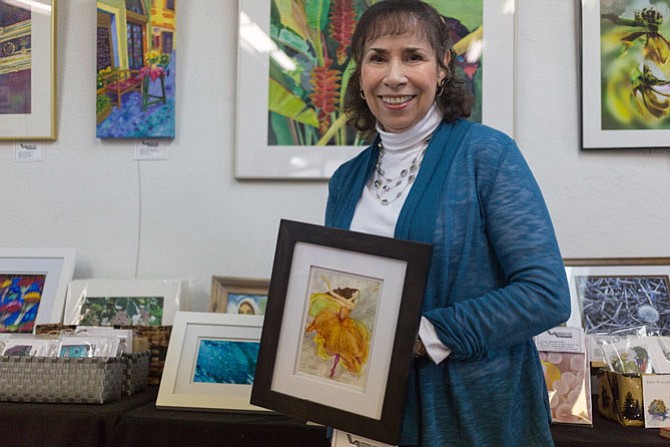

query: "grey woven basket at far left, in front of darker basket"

left=0, top=356, right=125, bottom=404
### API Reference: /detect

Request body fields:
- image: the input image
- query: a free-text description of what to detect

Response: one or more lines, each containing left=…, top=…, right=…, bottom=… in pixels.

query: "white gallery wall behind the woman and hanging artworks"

left=0, top=0, right=670, bottom=310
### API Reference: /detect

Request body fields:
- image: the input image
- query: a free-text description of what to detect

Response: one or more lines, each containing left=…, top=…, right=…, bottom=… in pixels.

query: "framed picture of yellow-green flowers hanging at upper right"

left=581, top=0, right=670, bottom=149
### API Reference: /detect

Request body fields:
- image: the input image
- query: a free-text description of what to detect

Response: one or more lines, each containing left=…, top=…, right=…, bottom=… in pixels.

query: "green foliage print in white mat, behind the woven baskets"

left=79, top=296, right=164, bottom=326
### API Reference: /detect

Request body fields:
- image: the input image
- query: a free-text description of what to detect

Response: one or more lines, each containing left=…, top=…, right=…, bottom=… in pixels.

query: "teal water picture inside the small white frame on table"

left=193, top=338, right=260, bottom=385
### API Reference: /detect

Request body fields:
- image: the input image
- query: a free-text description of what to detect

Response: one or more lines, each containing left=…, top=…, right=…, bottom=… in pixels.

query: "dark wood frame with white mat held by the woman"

left=251, top=220, right=431, bottom=444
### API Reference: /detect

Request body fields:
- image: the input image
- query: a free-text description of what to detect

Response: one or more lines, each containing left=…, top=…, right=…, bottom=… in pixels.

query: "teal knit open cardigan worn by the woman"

left=325, top=120, right=570, bottom=447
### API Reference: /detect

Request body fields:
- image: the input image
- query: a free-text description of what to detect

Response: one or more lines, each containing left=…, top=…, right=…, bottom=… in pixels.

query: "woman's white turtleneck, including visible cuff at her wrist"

left=350, top=104, right=451, bottom=363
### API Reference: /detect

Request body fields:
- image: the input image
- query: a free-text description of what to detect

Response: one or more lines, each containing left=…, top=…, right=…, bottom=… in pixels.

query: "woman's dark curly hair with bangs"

left=344, top=0, right=474, bottom=133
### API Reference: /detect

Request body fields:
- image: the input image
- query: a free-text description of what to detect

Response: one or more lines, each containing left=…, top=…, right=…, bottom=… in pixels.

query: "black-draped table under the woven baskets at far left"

left=0, top=389, right=156, bottom=447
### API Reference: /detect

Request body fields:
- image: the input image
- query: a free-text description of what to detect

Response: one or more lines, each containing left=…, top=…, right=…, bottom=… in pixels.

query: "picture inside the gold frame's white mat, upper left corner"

left=0, top=0, right=32, bottom=115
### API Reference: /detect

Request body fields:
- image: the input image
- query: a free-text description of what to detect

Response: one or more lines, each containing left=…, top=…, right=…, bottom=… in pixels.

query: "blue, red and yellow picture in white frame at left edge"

left=0, top=273, right=46, bottom=333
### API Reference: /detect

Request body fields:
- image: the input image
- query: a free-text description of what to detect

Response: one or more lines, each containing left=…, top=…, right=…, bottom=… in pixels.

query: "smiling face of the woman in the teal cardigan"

left=361, top=33, right=449, bottom=132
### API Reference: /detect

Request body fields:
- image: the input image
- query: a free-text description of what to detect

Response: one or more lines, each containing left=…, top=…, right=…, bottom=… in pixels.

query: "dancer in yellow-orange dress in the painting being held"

left=305, top=278, right=370, bottom=378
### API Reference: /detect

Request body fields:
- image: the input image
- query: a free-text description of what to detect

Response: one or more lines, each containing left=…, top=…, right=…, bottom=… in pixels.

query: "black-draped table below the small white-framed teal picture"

left=107, top=403, right=330, bottom=447
